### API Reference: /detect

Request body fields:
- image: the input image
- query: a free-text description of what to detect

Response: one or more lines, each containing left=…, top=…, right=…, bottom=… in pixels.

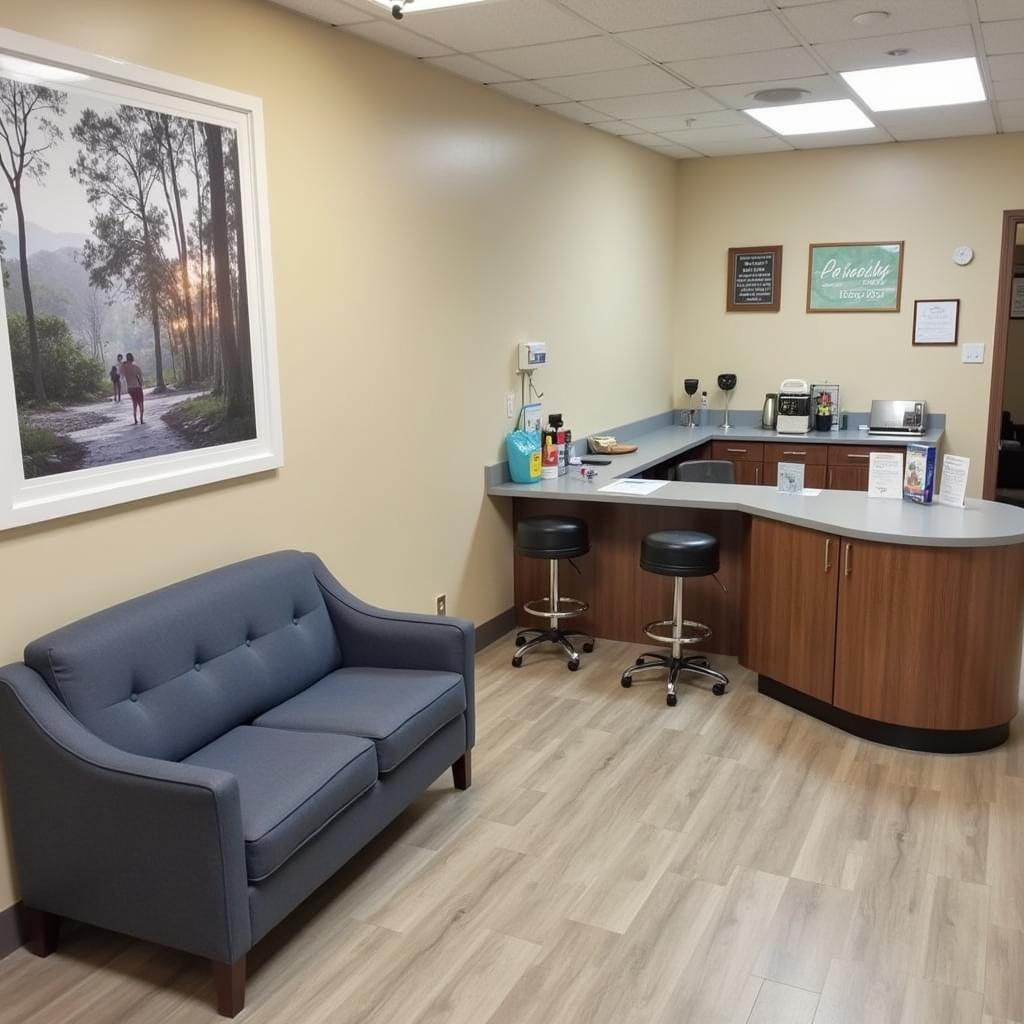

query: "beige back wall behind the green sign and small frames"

left=675, top=135, right=1024, bottom=496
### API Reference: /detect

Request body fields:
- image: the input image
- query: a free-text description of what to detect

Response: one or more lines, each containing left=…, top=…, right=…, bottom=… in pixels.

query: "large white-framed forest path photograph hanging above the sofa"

left=0, top=30, right=283, bottom=529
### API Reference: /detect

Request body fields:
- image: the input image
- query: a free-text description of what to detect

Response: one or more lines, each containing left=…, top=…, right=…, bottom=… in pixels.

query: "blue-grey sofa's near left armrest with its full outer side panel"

left=0, top=665, right=251, bottom=963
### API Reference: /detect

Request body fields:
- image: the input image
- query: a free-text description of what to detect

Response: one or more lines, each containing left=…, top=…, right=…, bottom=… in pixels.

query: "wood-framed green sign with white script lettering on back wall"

left=807, top=242, right=903, bottom=313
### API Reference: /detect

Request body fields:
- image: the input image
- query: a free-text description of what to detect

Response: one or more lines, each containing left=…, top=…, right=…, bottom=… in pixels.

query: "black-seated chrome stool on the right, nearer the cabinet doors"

left=622, top=529, right=729, bottom=708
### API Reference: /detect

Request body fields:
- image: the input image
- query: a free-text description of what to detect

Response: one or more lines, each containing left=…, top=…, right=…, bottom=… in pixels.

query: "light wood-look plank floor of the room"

left=0, top=638, right=1024, bottom=1024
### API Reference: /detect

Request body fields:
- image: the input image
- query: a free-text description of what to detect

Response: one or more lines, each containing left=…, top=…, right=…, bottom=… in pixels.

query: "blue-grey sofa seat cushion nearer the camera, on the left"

left=184, top=725, right=377, bottom=882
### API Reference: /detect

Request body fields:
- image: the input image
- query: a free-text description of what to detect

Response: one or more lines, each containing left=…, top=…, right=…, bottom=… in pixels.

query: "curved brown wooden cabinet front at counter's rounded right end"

left=835, top=540, right=1024, bottom=729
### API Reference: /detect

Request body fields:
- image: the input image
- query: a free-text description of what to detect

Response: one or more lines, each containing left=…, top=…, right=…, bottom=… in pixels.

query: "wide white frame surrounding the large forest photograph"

left=0, top=29, right=284, bottom=530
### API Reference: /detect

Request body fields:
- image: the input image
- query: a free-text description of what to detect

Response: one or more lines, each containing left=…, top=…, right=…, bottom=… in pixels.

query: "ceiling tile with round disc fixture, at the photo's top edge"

left=785, top=0, right=971, bottom=43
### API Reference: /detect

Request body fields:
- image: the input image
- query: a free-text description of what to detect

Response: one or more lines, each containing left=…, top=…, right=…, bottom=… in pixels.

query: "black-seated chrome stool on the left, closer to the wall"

left=512, top=516, right=594, bottom=672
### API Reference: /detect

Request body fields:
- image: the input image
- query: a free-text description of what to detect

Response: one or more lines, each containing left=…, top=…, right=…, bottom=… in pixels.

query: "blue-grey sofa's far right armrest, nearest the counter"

left=308, top=554, right=476, bottom=750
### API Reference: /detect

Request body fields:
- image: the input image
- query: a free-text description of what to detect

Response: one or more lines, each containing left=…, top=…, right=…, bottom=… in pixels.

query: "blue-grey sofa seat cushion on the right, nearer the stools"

left=253, top=669, right=466, bottom=773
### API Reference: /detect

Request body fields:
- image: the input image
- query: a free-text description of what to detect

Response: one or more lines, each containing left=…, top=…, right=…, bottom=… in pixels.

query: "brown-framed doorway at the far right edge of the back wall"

left=982, top=210, right=1024, bottom=507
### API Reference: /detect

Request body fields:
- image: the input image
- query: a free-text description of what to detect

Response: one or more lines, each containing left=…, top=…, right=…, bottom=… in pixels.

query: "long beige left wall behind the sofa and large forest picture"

left=0, top=0, right=677, bottom=908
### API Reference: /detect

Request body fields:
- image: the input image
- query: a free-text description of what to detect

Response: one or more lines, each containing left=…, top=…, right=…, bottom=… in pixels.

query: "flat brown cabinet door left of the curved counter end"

left=743, top=516, right=840, bottom=703
